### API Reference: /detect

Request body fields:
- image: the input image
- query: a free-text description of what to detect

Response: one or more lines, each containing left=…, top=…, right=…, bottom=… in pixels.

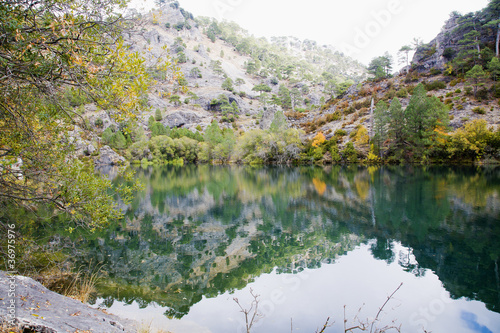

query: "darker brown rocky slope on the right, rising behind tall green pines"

left=296, top=1, right=500, bottom=160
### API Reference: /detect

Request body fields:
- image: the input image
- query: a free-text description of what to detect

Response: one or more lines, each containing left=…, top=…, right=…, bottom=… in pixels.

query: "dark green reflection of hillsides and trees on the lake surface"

left=81, top=166, right=500, bottom=331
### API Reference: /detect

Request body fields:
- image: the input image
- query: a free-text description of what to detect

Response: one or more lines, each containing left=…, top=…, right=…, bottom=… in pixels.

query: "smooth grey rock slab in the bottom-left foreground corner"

left=0, top=271, right=139, bottom=333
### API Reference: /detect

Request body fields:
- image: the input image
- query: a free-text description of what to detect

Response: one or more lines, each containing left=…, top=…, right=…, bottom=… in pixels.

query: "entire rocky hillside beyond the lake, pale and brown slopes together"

left=70, top=2, right=500, bottom=164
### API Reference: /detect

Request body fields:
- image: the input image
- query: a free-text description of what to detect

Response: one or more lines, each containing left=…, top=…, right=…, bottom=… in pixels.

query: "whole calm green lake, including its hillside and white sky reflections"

left=78, top=165, right=500, bottom=333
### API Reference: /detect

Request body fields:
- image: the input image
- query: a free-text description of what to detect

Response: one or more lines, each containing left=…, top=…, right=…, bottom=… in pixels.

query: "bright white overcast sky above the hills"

left=134, top=0, right=488, bottom=67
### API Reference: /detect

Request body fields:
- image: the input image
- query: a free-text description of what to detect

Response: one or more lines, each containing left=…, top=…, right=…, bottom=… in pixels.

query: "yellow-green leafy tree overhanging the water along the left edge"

left=0, top=0, right=179, bottom=229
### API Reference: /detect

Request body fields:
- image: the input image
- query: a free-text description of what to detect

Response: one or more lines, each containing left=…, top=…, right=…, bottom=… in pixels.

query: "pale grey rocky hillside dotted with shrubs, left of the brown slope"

left=78, top=2, right=367, bottom=143
